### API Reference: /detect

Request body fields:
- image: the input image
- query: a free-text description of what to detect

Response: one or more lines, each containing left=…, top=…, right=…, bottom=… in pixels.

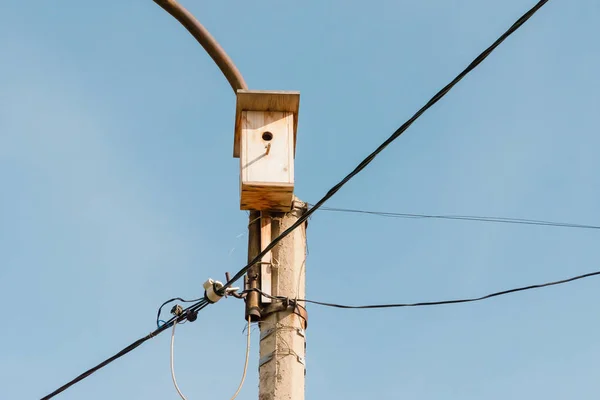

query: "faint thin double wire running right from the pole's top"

left=320, top=207, right=600, bottom=229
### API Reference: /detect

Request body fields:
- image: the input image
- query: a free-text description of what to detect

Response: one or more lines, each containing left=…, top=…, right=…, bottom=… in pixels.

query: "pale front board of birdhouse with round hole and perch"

left=240, top=111, right=294, bottom=185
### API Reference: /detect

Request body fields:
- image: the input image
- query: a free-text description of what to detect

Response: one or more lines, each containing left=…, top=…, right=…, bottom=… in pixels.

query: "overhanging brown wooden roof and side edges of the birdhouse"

left=233, top=89, right=300, bottom=158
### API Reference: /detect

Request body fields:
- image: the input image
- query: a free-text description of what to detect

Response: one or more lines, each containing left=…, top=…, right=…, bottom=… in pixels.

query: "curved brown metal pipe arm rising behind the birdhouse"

left=154, top=0, right=248, bottom=93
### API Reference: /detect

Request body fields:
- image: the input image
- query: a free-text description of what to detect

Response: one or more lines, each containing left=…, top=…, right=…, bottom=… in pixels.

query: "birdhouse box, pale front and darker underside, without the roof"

left=240, top=111, right=294, bottom=211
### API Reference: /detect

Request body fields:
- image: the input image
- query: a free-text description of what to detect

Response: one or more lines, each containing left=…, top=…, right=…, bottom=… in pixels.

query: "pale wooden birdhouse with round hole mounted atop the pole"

left=233, top=90, right=300, bottom=211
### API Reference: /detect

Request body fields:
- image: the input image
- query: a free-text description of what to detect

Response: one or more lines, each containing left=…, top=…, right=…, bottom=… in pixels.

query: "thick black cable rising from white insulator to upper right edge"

left=223, top=0, right=548, bottom=289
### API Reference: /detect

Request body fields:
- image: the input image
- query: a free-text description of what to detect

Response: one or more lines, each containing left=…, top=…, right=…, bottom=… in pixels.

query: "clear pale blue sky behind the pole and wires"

left=0, top=0, right=600, bottom=400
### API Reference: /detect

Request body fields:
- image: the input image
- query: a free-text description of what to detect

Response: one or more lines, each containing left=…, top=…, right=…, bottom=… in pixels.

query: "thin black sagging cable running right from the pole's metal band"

left=243, top=271, right=600, bottom=309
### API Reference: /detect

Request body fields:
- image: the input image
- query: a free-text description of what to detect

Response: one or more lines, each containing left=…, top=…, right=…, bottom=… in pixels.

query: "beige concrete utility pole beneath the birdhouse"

left=258, top=199, right=307, bottom=400
